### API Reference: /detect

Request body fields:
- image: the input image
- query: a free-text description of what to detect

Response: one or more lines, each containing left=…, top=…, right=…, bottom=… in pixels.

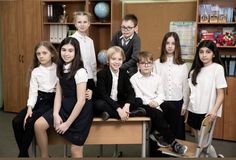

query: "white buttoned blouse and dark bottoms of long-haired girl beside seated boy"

left=154, top=56, right=189, bottom=140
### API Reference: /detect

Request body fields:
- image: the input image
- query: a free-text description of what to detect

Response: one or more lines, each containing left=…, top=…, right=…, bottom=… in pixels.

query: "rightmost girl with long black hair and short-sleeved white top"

left=187, top=40, right=227, bottom=157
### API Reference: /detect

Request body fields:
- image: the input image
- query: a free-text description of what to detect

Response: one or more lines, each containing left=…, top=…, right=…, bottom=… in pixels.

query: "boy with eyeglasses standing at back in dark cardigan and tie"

left=111, top=14, right=141, bottom=77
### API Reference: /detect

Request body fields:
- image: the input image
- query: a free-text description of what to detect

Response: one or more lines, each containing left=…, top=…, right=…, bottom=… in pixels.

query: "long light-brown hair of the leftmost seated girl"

left=27, top=41, right=58, bottom=82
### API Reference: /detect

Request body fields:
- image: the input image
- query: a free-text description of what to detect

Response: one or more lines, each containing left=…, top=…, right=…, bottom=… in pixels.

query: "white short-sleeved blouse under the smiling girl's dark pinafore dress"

left=63, top=63, right=88, bottom=84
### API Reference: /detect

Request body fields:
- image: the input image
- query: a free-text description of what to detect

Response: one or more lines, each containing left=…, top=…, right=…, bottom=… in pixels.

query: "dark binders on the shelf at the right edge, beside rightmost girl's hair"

left=221, top=55, right=236, bottom=77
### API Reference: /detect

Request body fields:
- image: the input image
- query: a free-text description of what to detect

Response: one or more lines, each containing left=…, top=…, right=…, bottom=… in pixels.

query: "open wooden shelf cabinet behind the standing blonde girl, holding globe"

left=42, top=0, right=121, bottom=53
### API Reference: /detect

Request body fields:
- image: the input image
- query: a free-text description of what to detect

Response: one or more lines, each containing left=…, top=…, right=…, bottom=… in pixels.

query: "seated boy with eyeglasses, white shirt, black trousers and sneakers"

left=130, top=51, right=188, bottom=155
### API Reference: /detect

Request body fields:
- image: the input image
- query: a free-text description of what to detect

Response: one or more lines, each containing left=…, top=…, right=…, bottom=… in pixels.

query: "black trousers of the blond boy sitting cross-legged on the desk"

left=94, top=98, right=142, bottom=119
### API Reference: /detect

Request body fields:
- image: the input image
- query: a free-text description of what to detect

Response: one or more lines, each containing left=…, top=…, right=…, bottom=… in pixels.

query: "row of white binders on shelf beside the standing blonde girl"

left=49, top=24, right=68, bottom=43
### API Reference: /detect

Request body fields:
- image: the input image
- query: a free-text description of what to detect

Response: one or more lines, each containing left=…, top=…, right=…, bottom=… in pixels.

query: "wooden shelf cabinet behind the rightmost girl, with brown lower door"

left=196, top=0, right=236, bottom=141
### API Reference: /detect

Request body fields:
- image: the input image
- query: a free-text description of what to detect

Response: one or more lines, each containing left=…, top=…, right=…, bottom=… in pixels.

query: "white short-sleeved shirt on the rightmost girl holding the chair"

left=188, top=63, right=227, bottom=117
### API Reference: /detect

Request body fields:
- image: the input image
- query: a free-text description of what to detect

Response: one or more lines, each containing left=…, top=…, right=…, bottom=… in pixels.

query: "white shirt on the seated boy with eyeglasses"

left=130, top=71, right=165, bottom=105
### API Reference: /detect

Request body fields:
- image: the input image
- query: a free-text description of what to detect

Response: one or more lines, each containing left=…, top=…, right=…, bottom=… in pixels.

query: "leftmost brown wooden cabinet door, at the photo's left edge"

left=1, top=0, right=22, bottom=112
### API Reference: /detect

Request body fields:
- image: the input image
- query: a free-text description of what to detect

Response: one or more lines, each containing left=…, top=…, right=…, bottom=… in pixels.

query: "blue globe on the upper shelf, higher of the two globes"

left=94, top=2, right=110, bottom=19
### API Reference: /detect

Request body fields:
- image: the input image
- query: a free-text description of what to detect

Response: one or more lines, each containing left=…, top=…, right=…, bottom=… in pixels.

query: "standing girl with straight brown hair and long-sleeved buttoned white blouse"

left=154, top=32, right=189, bottom=139
